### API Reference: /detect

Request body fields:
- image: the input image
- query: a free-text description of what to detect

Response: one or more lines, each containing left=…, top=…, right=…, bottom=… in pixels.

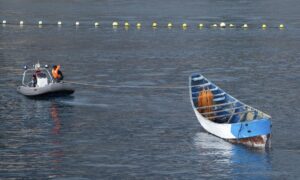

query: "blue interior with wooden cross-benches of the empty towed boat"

left=190, top=74, right=267, bottom=124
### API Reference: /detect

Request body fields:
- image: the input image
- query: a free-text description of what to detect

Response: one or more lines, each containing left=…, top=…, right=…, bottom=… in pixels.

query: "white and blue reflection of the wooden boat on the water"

left=194, top=132, right=272, bottom=179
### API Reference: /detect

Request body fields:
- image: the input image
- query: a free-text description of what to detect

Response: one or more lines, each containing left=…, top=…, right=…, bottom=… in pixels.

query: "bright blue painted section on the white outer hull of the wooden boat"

left=231, top=119, right=271, bottom=139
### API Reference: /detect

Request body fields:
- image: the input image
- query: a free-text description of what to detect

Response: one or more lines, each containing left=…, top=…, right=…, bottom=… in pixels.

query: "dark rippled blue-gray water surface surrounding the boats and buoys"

left=0, top=0, right=300, bottom=179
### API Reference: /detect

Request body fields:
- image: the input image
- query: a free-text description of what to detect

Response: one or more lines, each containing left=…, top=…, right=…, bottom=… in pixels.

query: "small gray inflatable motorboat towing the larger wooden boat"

left=17, top=63, right=75, bottom=97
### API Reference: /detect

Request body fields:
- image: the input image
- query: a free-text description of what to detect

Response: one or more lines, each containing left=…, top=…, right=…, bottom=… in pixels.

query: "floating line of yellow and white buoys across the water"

left=0, top=20, right=285, bottom=30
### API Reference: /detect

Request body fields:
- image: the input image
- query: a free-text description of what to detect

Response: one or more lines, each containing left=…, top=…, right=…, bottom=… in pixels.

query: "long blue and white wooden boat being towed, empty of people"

left=189, top=74, right=271, bottom=148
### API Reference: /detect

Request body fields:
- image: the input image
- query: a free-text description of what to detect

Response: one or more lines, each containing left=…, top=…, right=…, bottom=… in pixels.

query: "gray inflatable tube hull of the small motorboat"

left=17, top=83, right=75, bottom=97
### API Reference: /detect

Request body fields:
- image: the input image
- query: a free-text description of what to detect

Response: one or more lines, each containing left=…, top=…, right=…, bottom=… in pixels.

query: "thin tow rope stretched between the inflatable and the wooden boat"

left=64, top=81, right=188, bottom=89
